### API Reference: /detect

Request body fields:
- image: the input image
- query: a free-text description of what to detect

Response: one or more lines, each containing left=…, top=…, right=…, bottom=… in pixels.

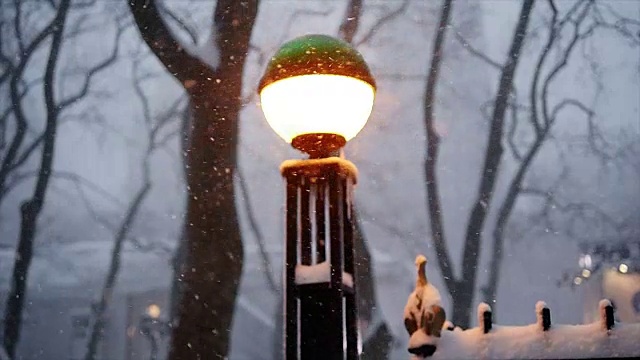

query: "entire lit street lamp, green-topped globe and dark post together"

left=258, top=35, right=375, bottom=360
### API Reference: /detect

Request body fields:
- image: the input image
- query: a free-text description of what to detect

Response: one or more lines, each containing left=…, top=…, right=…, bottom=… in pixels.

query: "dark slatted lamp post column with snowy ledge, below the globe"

left=281, top=157, right=358, bottom=360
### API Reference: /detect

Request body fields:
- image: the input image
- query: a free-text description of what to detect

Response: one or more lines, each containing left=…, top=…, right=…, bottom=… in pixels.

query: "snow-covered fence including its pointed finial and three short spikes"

left=404, top=255, right=640, bottom=359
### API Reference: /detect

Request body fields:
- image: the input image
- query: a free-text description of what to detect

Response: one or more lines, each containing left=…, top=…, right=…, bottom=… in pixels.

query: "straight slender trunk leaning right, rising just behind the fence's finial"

left=453, top=0, right=534, bottom=327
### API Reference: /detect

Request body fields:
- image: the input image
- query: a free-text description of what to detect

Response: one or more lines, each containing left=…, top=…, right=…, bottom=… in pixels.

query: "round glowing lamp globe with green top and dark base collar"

left=258, top=35, right=376, bottom=158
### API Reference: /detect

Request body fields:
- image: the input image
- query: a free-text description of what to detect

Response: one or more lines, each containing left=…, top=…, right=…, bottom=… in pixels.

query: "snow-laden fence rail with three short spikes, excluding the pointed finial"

left=413, top=300, right=640, bottom=359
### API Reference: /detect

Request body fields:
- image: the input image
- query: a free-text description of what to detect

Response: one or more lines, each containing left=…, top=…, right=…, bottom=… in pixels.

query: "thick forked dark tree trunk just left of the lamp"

left=129, top=0, right=258, bottom=360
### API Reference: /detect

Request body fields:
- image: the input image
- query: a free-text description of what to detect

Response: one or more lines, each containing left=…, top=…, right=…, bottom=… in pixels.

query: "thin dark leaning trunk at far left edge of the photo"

left=4, top=0, right=70, bottom=358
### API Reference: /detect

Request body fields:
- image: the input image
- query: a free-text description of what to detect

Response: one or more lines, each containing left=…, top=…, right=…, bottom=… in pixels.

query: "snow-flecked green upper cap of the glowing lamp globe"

left=258, top=35, right=376, bottom=93
